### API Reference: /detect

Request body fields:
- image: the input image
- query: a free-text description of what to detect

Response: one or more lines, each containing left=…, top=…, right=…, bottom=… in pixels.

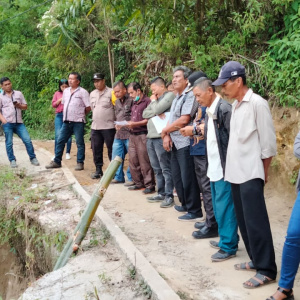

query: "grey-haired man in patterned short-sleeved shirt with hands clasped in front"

left=161, top=66, right=203, bottom=221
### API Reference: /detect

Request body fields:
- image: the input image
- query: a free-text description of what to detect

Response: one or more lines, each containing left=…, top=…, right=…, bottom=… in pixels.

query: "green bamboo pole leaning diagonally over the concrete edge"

left=54, top=156, right=122, bottom=270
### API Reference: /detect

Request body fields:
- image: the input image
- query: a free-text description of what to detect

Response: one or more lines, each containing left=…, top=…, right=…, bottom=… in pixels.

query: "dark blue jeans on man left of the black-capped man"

left=54, top=122, right=85, bottom=165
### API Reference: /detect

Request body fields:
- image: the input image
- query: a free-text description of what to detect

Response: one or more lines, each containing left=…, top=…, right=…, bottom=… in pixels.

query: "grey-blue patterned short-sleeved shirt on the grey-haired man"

left=169, top=87, right=198, bottom=149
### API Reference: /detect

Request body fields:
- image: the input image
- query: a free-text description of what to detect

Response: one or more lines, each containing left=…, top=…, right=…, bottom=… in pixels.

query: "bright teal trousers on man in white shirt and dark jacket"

left=210, top=178, right=239, bottom=254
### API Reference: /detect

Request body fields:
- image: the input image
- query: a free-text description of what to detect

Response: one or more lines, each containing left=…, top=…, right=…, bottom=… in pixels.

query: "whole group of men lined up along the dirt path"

left=0, top=61, right=277, bottom=288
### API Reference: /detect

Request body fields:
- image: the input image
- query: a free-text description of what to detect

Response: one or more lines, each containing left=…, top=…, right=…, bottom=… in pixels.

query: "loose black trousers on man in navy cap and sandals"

left=231, top=178, right=277, bottom=279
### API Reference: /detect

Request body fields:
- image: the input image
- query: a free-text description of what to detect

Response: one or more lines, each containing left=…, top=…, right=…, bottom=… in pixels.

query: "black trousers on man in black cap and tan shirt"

left=91, top=128, right=116, bottom=168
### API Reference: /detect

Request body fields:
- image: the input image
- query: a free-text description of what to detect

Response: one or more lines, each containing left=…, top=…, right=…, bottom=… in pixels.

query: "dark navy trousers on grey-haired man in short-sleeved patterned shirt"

left=171, top=145, right=202, bottom=215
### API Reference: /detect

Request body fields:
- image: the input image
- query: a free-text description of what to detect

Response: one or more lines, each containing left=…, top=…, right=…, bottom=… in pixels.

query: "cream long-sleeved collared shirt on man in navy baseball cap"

left=225, top=89, right=276, bottom=184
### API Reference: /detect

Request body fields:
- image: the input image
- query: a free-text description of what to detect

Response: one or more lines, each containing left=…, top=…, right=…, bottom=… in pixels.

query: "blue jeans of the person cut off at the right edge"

left=279, top=192, right=300, bottom=289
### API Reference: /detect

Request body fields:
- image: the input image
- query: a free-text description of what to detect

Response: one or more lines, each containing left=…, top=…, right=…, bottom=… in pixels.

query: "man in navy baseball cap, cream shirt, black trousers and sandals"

left=213, top=61, right=277, bottom=288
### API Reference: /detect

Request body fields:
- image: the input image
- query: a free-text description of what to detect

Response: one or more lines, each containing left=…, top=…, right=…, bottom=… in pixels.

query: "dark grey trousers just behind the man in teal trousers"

left=193, top=155, right=217, bottom=227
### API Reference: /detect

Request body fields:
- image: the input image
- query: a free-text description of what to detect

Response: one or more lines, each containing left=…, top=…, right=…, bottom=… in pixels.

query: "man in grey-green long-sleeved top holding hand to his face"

left=143, top=77, right=175, bottom=208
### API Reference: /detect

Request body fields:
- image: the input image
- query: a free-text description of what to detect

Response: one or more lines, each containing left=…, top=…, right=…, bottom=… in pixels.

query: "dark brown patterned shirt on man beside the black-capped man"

left=115, top=95, right=133, bottom=140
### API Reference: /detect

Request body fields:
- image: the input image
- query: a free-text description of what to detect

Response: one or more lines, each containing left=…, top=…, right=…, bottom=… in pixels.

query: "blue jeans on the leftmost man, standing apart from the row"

left=3, top=123, right=36, bottom=161
